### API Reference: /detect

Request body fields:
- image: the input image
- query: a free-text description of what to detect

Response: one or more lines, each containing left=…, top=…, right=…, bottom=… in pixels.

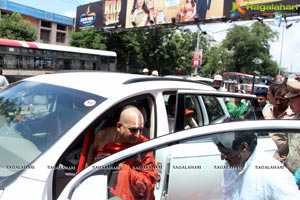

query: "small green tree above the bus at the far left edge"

left=0, top=13, right=37, bottom=41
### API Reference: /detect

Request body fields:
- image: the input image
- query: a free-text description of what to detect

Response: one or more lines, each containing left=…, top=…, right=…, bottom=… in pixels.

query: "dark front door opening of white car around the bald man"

left=53, top=95, right=156, bottom=198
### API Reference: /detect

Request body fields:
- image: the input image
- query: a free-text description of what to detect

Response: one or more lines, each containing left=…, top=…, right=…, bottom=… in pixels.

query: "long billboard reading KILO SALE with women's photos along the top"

left=76, top=0, right=300, bottom=31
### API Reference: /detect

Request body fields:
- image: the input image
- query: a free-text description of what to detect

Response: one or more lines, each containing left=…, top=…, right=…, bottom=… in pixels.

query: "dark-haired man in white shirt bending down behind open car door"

left=213, top=132, right=300, bottom=200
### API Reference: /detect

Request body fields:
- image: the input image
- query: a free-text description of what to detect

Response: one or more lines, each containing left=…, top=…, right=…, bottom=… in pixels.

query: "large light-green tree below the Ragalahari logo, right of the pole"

left=223, top=22, right=278, bottom=75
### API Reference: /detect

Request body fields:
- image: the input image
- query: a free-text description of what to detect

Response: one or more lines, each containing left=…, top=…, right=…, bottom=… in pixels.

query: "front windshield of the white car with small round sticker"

left=0, top=81, right=105, bottom=182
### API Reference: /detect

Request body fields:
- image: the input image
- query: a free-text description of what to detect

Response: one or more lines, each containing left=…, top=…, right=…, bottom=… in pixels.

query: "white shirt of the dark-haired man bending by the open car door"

left=223, top=150, right=300, bottom=200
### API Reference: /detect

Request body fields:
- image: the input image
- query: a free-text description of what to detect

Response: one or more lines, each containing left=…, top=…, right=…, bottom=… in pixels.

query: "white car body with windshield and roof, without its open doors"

left=0, top=72, right=255, bottom=199
